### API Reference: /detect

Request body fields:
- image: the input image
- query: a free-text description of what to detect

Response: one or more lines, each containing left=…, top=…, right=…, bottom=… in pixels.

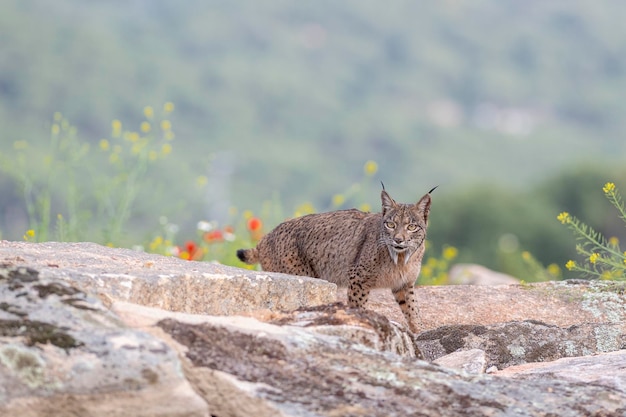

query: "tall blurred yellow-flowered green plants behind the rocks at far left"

left=0, top=103, right=174, bottom=245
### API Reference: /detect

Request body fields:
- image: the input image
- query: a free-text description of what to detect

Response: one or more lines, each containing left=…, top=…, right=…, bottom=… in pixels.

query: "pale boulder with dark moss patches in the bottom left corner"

left=0, top=266, right=208, bottom=417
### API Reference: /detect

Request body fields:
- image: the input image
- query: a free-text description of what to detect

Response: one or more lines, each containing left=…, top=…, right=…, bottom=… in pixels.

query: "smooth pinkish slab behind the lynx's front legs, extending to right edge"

left=337, top=280, right=626, bottom=334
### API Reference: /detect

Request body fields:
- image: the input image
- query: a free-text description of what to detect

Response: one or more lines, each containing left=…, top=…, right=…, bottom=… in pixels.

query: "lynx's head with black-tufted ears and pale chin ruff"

left=380, top=186, right=437, bottom=265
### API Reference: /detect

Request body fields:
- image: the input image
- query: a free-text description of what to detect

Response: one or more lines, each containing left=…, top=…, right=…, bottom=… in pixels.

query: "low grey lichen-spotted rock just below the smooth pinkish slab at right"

left=415, top=321, right=626, bottom=369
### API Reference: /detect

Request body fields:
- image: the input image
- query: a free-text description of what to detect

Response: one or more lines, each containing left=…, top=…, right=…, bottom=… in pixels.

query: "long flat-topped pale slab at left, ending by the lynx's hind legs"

left=0, top=241, right=337, bottom=315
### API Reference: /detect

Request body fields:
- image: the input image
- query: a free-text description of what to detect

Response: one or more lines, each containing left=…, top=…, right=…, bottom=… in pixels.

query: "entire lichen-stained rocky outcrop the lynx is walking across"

left=0, top=242, right=626, bottom=417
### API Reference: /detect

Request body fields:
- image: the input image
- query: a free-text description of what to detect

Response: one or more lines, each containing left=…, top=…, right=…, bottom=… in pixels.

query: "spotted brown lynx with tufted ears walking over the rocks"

left=237, top=185, right=437, bottom=332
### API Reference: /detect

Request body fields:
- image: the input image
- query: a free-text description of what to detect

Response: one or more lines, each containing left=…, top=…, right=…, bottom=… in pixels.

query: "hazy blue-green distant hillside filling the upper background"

left=0, top=0, right=626, bottom=244
